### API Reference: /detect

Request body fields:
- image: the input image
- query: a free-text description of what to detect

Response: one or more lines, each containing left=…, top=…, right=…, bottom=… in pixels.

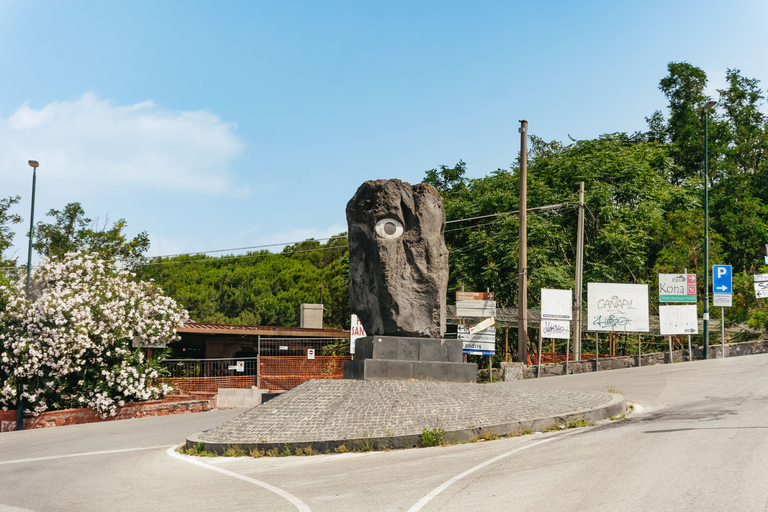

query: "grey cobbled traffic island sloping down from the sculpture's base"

left=187, top=380, right=626, bottom=451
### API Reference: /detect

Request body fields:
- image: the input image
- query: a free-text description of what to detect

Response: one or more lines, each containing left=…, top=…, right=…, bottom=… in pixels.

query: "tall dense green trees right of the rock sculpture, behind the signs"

left=426, top=63, right=768, bottom=340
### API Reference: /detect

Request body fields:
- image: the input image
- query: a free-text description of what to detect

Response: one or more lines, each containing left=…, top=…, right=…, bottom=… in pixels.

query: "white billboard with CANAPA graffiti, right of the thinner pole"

left=587, top=283, right=650, bottom=332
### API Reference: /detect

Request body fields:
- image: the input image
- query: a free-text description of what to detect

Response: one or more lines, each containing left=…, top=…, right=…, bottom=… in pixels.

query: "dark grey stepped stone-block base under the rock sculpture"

left=344, top=336, right=477, bottom=382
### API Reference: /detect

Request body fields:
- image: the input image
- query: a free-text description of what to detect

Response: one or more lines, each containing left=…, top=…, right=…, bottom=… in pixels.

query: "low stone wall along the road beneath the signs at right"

left=501, top=340, right=768, bottom=380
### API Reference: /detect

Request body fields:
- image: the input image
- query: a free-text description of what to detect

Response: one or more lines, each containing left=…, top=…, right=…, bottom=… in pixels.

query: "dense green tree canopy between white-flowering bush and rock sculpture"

left=139, top=235, right=350, bottom=328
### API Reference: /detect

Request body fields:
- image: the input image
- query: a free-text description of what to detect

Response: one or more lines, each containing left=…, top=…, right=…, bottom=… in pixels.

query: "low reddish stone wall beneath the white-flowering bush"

left=0, top=393, right=216, bottom=432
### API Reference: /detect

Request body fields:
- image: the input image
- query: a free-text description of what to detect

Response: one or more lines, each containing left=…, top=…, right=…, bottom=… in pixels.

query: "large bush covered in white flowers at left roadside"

left=0, top=253, right=187, bottom=417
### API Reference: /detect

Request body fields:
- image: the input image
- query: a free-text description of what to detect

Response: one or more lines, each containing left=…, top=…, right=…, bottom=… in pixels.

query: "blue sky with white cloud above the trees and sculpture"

left=0, top=0, right=768, bottom=261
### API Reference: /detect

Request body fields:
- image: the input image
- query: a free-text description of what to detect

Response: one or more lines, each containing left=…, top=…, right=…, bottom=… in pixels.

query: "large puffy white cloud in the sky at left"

left=0, top=93, right=243, bottom=198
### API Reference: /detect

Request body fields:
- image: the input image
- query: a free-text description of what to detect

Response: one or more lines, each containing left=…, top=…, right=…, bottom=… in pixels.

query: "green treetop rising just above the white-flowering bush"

left=33, top=203, right=149, bottom=268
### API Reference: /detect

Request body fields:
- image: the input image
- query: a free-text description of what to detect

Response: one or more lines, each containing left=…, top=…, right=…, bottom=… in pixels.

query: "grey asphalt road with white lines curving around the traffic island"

left=0, top=355, right=768, bottom=512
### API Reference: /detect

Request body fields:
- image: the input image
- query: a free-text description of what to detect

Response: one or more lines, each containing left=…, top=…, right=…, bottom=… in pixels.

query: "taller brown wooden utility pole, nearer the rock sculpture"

left=517, top=119, right=528, bottom=364
